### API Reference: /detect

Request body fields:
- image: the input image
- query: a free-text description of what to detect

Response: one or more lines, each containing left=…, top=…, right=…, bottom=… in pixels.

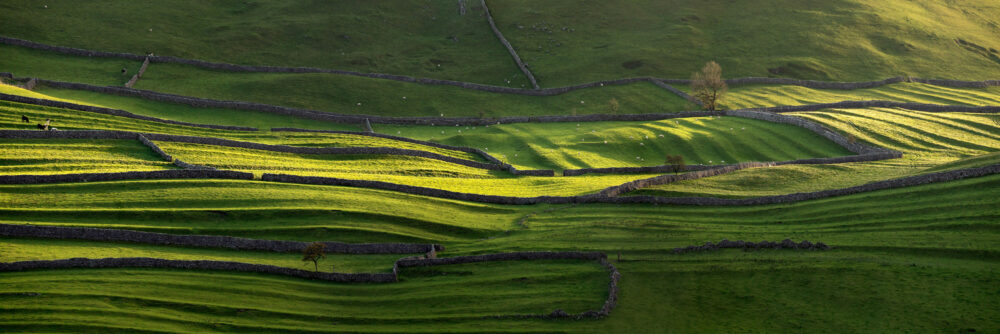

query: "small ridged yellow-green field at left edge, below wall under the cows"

left=0, top=138, right=175, bottom=175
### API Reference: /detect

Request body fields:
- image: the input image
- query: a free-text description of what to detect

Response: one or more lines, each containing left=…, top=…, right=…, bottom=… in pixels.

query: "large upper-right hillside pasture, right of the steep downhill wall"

left=490, top=0, right=1000, bottom=86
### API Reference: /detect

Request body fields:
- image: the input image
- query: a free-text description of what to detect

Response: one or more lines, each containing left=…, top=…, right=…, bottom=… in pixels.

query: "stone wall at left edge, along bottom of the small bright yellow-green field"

left=0, top=169, right=253, bottom=184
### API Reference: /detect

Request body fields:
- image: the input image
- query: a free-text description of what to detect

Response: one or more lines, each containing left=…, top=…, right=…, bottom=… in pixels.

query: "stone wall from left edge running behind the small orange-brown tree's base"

left=0, top=257, right=396, bottom=283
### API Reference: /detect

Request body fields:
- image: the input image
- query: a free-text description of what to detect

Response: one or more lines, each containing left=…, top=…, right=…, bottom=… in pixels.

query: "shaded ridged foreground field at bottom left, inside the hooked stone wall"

left=0, top=261, right=608, bottom=332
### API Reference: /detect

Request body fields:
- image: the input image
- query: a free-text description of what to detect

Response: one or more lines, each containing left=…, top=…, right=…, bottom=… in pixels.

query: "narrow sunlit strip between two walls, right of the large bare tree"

left=716, top=83, right=1000, bottom=109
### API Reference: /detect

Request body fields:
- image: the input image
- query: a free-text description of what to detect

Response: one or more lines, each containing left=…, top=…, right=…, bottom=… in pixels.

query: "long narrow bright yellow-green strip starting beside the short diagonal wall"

left=152, top=143, right=657, bottom=197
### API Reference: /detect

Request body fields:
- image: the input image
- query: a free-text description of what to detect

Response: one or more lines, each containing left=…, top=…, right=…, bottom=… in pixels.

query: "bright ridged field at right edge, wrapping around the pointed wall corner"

left=635, top=109, right=1000, bottom=197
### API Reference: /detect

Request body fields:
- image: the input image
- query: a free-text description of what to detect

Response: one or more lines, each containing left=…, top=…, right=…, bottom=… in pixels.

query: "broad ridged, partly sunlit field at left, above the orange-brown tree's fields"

left=0, top=180, right=530, bottom=242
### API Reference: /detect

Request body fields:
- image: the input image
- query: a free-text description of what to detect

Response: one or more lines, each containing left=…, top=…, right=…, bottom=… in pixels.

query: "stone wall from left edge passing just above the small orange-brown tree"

left=0, top=224, right=444, bottom=254
